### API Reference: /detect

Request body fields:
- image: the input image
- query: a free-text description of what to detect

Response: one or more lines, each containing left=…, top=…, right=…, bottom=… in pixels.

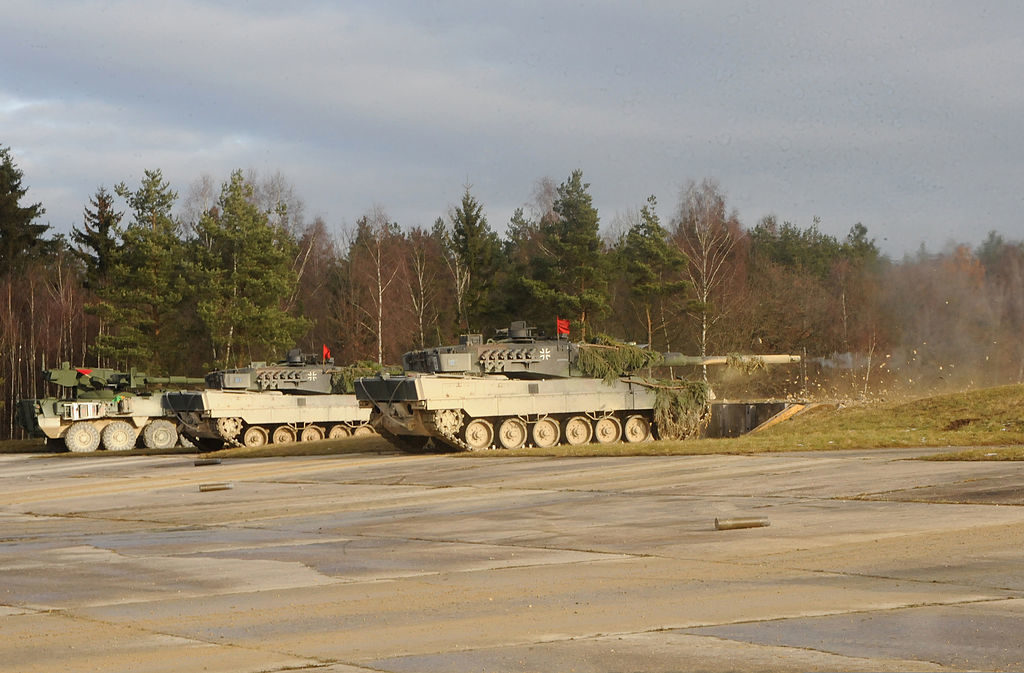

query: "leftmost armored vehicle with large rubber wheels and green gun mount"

left=17, top=363, right=203, bottom=453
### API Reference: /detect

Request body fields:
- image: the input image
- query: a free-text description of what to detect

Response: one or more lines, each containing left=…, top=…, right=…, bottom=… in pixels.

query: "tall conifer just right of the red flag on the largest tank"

left=523, top=165, right=608, bottom=339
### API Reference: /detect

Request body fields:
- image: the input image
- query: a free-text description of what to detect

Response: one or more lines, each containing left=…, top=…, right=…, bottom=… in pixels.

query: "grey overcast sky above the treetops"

left=0, top=0, right=1024, bottom=258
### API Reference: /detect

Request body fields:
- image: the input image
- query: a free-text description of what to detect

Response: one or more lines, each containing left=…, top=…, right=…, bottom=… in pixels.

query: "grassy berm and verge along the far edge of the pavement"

left=8, top=385, right=1024, bottom=460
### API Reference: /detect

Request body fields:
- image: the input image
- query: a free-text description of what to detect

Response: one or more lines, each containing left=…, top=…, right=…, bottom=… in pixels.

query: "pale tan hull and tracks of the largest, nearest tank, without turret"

left=355, top=374, right=656, bottom=450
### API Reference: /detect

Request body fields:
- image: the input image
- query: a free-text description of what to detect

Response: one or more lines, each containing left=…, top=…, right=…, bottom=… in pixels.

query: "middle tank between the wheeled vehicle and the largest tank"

left=167, top=349, right=374, bottom=450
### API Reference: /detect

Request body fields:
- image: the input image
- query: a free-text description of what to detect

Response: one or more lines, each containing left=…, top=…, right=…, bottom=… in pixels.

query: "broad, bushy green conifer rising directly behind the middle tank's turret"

left=189, top=171, right=309, bottom=368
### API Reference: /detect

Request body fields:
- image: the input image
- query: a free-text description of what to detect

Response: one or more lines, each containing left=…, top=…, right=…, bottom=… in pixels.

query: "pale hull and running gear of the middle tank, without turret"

left=168, top=389, right=373, bottom=449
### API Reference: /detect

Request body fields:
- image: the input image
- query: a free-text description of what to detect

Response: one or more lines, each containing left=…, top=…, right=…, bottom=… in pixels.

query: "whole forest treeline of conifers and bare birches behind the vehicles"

left=0, top=148, right=1024, bottom=434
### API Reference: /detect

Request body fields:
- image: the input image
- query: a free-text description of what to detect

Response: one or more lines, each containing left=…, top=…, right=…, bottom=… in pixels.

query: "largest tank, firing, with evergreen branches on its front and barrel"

left=355, top=322, right=800, bottom=450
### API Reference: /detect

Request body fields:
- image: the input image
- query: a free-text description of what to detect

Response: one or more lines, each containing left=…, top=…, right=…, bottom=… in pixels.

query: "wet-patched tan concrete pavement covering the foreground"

left=0, top=450, right=1024, bottom=673
